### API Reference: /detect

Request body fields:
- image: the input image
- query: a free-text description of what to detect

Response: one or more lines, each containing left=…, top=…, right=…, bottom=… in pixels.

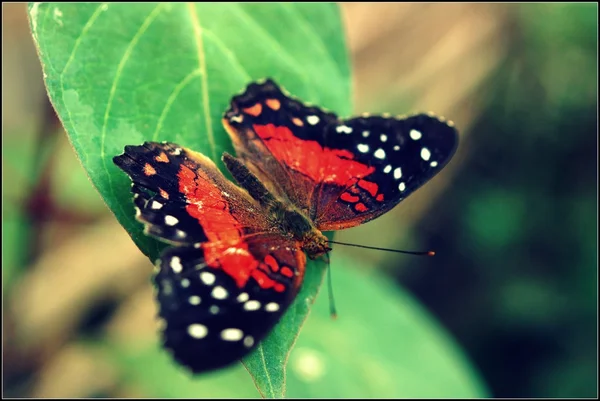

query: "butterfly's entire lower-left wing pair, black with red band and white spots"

left=114, top=142, right=306, bottom=372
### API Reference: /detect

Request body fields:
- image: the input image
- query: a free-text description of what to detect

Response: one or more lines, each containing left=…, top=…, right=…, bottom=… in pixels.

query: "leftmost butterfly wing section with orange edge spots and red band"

left=114, top=142, right=272, bottom=245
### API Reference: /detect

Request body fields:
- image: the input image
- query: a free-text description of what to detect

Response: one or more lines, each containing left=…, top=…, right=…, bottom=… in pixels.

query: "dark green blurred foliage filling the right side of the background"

left=396, top=4, right=598, bottom=397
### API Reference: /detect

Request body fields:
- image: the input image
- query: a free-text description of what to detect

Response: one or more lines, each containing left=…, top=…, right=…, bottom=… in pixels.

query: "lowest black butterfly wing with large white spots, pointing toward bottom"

left=154, top=236, right=306, bottom=373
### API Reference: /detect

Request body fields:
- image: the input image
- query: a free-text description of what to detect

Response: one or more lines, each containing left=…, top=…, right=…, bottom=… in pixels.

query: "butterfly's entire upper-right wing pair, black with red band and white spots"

left=223, top=80, right=458, bottom=231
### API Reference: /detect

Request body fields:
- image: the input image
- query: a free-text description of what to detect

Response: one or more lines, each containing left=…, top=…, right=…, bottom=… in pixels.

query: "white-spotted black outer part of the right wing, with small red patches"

left=314, top=114, right=458, bottom=231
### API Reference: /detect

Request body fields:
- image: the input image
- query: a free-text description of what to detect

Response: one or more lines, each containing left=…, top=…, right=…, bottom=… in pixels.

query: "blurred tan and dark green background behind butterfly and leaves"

left=2, top=3, right=598, bottom=397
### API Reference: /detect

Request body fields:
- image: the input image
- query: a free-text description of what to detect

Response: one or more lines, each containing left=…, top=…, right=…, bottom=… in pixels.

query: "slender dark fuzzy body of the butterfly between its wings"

left=223, top=153, right=331, bottom=259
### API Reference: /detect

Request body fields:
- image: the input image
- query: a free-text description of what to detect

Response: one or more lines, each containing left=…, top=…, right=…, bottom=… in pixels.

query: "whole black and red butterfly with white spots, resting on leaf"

left=113, top=79, right=458, bottom=373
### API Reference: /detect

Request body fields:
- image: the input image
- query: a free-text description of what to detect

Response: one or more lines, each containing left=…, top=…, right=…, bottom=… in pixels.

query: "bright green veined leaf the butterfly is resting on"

left=29, top=3, right=351, bottom=396
